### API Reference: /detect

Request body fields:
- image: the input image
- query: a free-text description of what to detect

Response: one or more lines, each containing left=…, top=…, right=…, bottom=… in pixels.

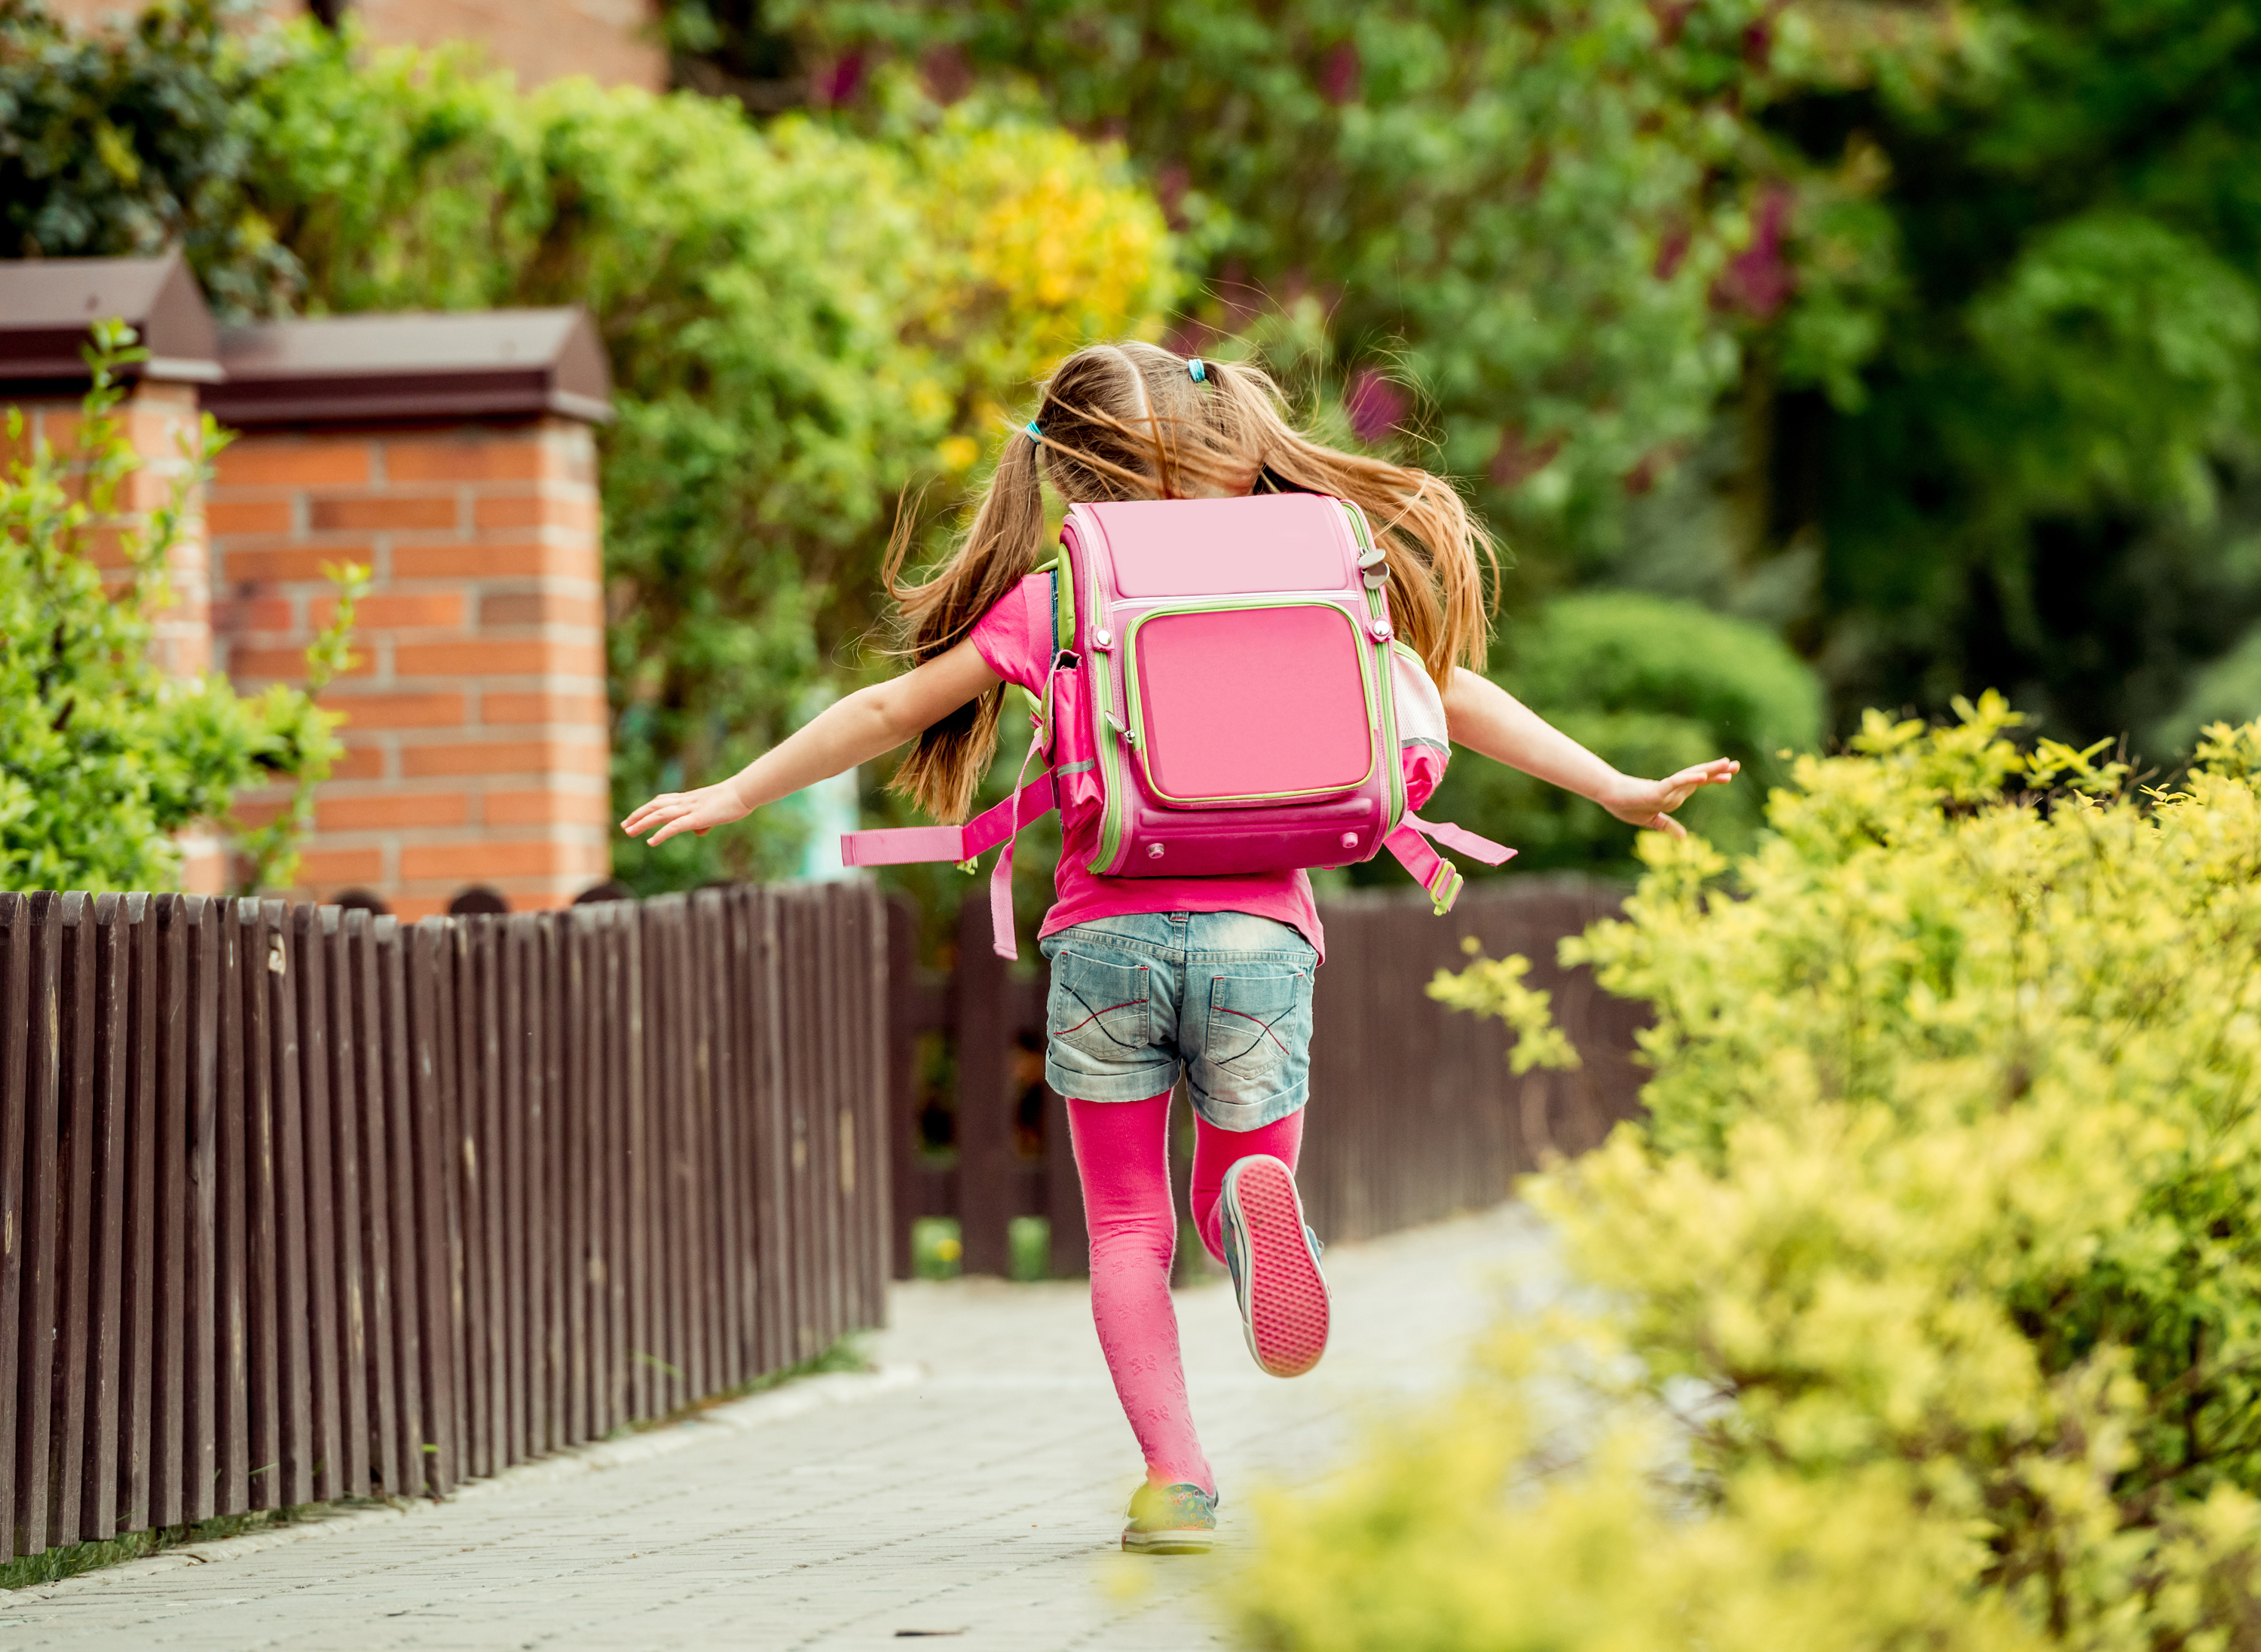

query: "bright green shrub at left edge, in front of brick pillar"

left=0, top=323, right=353, bottom=890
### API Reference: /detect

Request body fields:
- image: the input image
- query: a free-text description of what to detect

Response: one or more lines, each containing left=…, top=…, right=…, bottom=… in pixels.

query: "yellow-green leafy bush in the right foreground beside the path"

left=1232, top=696, right=2261, bottom=1652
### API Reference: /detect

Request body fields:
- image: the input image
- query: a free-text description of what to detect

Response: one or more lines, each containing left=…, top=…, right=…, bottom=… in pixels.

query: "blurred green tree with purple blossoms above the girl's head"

left=778, top=0, right=1818, bottom=574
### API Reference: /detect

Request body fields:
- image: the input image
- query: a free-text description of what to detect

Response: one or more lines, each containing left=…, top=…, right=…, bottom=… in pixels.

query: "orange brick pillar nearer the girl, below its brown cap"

left=208, top=416, right=610, bottom=917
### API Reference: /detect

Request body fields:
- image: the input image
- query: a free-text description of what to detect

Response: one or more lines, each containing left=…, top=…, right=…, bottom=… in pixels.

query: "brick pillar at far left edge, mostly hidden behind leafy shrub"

left=0, top=382, right=228, bottom=895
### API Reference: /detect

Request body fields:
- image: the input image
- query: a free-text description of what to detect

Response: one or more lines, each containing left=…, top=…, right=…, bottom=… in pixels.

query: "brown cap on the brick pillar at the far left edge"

left=0, top=253, right=219, bottom=393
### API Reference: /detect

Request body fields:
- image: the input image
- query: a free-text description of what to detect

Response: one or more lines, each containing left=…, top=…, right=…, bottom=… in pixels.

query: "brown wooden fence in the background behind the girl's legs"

left=889, top=876, right=1641, bottom=1279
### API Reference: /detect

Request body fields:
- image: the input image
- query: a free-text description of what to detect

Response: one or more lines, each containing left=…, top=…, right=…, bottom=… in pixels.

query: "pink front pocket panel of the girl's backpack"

left=1126, top=601, right=1377, bottom=809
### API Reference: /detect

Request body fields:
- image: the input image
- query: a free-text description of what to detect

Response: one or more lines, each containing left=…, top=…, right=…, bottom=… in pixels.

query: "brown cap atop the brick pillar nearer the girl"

left=203, top=310, right=613, bottom=427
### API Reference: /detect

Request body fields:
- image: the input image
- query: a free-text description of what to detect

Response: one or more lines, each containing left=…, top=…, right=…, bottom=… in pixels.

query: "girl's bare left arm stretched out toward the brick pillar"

left=620, top=642, right=1002, bottom=845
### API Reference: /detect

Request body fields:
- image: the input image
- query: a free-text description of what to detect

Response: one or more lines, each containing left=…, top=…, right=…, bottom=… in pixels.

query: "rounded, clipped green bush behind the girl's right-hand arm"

left=1431, top=592, right=1822, bottom=874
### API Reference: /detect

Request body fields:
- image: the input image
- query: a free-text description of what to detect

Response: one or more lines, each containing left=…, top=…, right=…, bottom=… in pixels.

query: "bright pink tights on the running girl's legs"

left=1067, top=1091, right=1302, bottom=1494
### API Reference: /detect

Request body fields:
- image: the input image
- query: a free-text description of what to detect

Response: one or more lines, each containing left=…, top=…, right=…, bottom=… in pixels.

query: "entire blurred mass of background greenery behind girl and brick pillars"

left=0, top=0, right=2261, bottom=888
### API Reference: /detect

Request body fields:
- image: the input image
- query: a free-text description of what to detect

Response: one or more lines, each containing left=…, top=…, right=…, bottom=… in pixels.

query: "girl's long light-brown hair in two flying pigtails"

left=884, top=344, right=1499, bottom=821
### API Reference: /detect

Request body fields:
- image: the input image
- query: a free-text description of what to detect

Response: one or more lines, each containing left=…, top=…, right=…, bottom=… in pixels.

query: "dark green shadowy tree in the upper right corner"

left=1743, top=0, right=2261, bottom=760
